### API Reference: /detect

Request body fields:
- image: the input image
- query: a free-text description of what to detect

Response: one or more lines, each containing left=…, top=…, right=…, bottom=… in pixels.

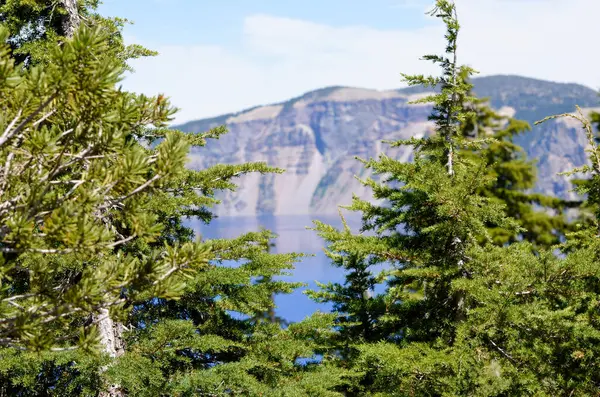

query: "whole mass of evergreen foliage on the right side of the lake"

left=309, top=0, right=600, bottom=396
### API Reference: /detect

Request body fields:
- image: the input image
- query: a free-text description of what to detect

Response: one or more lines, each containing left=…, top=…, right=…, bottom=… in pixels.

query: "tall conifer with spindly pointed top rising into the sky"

left=340, top=1, right=516, bottom=340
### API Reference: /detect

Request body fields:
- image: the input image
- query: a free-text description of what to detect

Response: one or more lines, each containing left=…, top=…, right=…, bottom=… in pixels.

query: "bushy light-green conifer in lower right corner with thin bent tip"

left=422, top=110, right=600, bottom=396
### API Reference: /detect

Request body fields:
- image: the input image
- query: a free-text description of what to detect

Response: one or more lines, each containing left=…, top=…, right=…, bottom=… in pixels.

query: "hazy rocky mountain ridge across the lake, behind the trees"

left=175, top=76, right=600, bottom=216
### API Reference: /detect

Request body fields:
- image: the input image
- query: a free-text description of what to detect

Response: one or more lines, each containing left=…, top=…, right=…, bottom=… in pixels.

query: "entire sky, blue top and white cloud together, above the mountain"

left=99, top=0, right=600, bottom=123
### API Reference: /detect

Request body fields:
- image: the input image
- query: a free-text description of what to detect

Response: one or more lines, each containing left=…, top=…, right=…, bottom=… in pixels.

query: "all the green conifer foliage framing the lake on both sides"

left=0, top=0, right=600, bottom=396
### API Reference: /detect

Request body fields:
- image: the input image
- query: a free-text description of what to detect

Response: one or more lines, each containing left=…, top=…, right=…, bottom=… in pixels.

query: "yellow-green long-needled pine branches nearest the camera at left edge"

left=0, top=24, right=210, bottom=349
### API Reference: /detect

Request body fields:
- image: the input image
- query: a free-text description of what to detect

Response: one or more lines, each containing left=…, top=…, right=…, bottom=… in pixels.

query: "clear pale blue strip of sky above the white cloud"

left=100, top=0, right=431, bottom=47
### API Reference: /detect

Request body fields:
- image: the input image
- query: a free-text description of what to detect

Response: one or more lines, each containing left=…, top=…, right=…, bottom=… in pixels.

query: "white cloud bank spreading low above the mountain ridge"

left=124, top=0, right=600, bottom=122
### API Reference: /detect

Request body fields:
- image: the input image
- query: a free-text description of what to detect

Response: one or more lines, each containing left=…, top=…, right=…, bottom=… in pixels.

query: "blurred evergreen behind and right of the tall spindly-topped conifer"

left=460, top=76, right=578, bottom=248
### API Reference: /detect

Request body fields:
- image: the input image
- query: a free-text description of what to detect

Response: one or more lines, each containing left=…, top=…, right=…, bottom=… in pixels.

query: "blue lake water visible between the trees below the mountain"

left=189, top=214, right=360, bottom=322
